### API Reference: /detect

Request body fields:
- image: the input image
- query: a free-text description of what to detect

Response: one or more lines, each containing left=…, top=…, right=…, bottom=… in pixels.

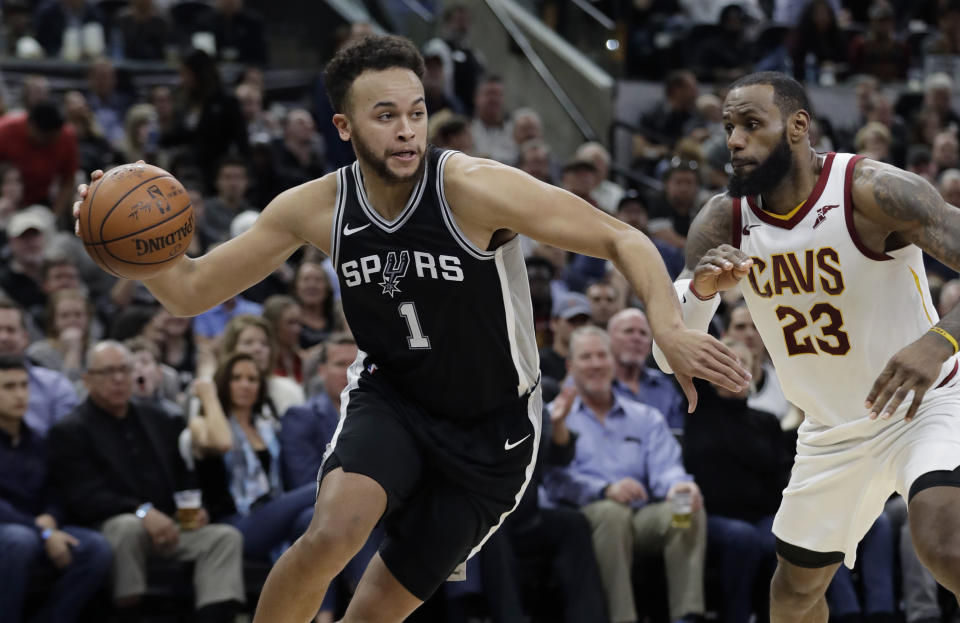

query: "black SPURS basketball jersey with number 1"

left=331, top=146, right=539, bottom=419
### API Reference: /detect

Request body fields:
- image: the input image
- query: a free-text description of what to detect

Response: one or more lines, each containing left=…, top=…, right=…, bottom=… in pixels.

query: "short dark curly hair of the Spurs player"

left=323, top=35, right=424, bottom=113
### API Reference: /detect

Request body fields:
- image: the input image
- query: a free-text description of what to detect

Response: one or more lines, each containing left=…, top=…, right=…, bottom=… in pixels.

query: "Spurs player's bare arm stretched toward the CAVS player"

left=444, top=156, right=750, bottom=407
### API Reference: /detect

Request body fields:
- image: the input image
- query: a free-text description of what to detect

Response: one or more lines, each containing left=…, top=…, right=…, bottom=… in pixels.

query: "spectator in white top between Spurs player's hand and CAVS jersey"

left=723, top=301, right=792, bottom=421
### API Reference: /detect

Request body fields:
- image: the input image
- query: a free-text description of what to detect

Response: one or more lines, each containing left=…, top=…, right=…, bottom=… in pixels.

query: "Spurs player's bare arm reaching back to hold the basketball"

left=74, top=176, right=337, bottom=316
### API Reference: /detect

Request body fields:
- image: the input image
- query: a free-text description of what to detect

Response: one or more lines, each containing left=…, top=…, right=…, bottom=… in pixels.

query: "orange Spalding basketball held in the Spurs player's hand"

left=78, top=164, right=194, bottom=279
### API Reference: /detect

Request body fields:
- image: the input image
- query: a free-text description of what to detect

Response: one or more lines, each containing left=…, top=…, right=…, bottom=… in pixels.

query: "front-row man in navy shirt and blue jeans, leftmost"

left=0, top=355, right=113, bottom=623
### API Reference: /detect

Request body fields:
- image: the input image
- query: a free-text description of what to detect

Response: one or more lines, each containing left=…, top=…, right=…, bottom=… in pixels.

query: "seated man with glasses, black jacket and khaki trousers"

left=49, top=341, right=244, bottom=623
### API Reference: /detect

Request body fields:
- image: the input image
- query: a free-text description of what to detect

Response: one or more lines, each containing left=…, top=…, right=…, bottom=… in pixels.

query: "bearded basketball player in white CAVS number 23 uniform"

left=655, top=72, right=960, bottom=623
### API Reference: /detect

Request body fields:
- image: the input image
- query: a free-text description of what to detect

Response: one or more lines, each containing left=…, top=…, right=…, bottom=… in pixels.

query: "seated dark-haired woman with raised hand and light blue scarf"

left=188, top=353, right=317, bottom=560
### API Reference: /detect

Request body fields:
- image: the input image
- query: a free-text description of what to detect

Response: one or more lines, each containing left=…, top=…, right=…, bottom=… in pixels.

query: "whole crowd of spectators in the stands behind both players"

left=0, top=0, right=960, bottom=623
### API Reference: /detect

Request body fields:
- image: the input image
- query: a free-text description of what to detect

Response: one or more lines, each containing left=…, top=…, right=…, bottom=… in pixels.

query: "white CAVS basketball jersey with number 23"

left=733, top=153, right=957, bottom=426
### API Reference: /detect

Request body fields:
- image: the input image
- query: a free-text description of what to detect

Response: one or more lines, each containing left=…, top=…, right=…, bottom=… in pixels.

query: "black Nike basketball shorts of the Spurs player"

left=319, top=371, right=541, bottom=600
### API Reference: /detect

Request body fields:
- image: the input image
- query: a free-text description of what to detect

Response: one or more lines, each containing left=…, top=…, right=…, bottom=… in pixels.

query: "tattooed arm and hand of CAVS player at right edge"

left=853, top=159, right=960, bottom=421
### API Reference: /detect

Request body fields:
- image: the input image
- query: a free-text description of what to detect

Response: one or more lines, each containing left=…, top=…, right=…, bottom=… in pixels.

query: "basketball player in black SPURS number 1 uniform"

left=73, top=36, right=749, bottom=623
